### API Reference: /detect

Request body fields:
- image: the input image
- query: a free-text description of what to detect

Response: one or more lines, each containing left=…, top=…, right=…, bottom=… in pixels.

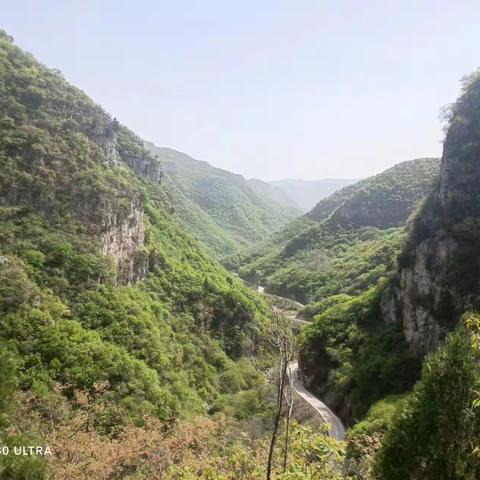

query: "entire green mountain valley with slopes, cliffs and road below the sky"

left=0, top=21, right=480, bottom=480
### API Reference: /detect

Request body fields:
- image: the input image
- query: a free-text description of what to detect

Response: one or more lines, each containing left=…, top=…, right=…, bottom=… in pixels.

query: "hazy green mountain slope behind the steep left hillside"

left=145, top=142, right=300, bottom=255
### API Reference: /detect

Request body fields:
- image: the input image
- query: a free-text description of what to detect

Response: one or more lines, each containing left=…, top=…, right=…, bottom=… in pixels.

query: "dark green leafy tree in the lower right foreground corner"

left=375, top=315, right=480, bottom=480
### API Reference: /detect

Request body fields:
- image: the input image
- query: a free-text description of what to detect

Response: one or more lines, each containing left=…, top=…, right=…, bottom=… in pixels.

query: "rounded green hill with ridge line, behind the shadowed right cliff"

left=240, top=159, right=439, bottom=302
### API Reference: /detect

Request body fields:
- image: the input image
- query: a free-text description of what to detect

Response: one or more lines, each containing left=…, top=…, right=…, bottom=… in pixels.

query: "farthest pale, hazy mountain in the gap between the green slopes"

left=268, top=178, right=357, bottom=213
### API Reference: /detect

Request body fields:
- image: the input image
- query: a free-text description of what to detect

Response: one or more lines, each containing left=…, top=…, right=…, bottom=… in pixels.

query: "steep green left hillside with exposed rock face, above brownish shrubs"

left=0, top=32, right=274, bottom=479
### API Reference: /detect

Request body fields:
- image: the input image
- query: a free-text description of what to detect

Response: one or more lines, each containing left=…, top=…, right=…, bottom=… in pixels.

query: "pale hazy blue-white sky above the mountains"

left=0, top=0, right=480, bottom=180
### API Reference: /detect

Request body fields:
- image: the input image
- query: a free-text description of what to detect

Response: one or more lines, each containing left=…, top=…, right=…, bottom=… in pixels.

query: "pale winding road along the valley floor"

left=258, top=287, right=345, bottom=440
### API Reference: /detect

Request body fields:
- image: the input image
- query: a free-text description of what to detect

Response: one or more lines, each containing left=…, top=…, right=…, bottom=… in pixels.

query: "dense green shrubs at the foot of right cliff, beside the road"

left=301, top=281, right=421, bottom=422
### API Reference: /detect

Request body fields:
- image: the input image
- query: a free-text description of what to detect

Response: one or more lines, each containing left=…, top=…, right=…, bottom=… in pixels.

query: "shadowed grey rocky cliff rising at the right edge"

left=381, top=74, right=480, bottom=351
